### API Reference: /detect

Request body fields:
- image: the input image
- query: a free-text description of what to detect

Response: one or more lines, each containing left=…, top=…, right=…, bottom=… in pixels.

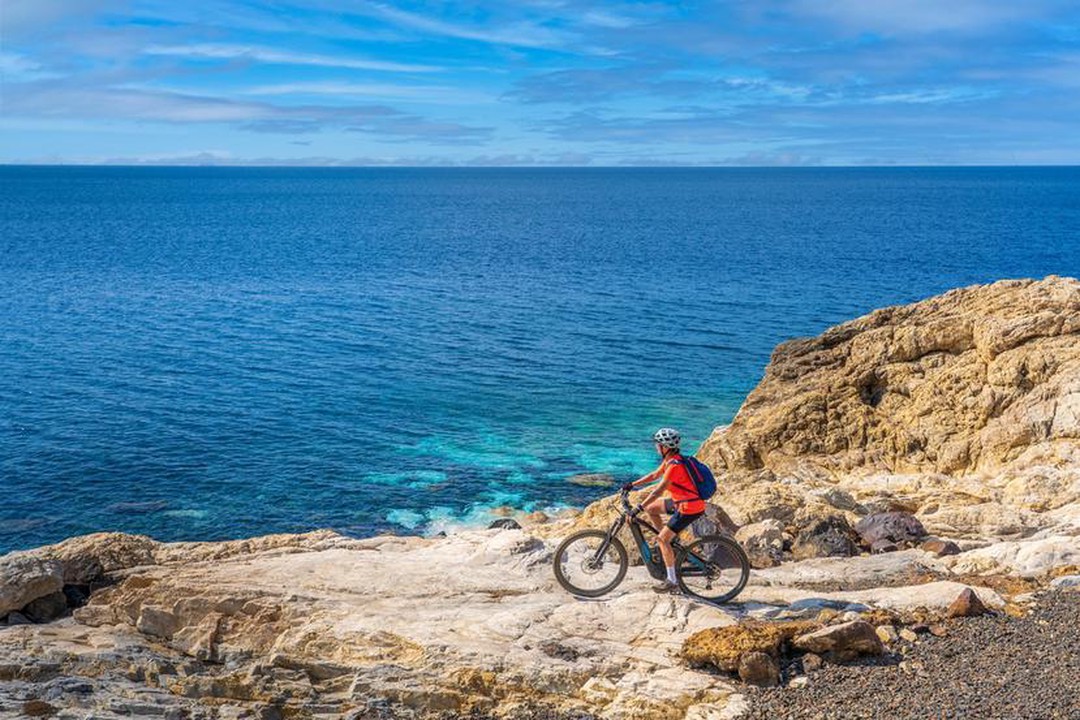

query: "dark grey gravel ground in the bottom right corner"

left=744, top=590, right=1080, bottom=720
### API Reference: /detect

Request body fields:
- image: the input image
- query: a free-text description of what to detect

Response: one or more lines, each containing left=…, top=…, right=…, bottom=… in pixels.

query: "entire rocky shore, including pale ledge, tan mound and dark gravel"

left=0, top=277, right=1080, bottom=720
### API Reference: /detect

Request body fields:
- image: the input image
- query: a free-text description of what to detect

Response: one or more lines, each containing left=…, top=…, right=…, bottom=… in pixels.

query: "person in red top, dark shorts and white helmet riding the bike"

left=623, top=427, right=705, bottom=593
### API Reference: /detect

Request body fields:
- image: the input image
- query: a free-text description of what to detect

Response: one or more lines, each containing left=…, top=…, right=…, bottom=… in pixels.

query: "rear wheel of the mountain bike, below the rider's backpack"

left=675, top=535, right=750, bottom=603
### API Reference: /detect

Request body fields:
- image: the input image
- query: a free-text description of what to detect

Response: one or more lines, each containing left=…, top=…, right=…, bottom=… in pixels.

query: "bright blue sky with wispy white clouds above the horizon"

left=0, top=0, right=1080, bottom=165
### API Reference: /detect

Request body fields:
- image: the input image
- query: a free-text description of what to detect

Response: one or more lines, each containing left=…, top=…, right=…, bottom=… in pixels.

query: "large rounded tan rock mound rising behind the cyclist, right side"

left=698, top=276, right=1080, bottom=539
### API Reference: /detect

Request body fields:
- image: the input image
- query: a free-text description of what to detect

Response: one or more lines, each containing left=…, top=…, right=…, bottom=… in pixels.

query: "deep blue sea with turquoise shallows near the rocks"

left=0, top=166, right=1080, bottom=553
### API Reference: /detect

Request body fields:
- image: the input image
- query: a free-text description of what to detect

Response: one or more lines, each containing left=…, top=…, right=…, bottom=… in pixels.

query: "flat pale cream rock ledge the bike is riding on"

left=0, top=520, right=1080, bottom=720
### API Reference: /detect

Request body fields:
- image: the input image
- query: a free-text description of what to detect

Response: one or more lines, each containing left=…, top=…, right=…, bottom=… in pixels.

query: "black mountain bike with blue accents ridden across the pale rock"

left=554, top=490, right=750, bottom=604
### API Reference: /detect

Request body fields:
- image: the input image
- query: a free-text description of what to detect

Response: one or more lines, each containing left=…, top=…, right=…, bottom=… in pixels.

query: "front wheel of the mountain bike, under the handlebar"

left=555, top=530, right=630, bottom=598
